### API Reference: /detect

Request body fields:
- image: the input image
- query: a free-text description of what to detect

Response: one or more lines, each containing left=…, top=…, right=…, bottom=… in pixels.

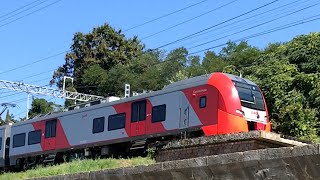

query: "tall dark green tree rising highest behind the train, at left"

left=51, top=24, right=144, bottom=95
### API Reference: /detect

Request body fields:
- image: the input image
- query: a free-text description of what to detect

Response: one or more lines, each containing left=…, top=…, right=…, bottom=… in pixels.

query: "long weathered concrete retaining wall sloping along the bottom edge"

left=34, top=145, right=320, bottom=180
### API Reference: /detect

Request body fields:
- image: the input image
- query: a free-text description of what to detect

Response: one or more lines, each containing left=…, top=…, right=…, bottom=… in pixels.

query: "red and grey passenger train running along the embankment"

left=0, top=73, right=271, bottom=168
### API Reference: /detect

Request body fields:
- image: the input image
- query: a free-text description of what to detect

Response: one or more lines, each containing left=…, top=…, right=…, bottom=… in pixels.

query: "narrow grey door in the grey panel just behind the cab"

left=179, top=95, right=189, bottom=129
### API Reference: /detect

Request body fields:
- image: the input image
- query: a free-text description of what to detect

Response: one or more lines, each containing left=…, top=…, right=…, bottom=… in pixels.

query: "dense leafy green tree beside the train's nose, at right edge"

left=242, top=34, right=320, bottom=139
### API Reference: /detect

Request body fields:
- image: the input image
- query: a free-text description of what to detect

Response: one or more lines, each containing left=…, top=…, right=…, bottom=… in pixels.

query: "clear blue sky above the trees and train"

left=0, top=0, right=320, bottom=119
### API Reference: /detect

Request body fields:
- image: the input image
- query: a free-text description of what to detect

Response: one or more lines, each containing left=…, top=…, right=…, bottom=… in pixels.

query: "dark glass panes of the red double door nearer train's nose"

left=131, top=100, right=147, bottom=122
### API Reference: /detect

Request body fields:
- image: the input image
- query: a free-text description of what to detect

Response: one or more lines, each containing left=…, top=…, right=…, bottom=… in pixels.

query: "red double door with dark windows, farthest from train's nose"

left=44, top=119, right=57, bottom=150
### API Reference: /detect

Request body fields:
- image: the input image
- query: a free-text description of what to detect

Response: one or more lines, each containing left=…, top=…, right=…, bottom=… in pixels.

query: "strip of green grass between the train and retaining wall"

left=0, top=157, right=155, bottom=180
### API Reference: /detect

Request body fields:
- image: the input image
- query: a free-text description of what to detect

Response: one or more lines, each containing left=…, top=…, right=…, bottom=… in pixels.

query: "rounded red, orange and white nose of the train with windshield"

left=203, top=73, right=271, bottom=135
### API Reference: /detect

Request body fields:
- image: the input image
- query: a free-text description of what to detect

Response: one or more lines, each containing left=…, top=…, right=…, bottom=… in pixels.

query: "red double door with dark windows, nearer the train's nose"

left=130, top=100, right=147, bottom=136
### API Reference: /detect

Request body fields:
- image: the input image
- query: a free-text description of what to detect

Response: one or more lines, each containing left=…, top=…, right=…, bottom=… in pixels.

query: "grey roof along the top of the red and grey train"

left=12, top=73, right=254, bottom=127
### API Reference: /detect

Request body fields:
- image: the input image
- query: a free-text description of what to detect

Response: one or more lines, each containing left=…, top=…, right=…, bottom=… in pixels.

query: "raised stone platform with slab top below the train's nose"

left=156, top=131, right=306, bottom=162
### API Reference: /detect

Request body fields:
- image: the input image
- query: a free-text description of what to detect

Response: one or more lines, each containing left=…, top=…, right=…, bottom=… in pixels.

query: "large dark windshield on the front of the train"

left=234, top=81, right=265, bottom=111
